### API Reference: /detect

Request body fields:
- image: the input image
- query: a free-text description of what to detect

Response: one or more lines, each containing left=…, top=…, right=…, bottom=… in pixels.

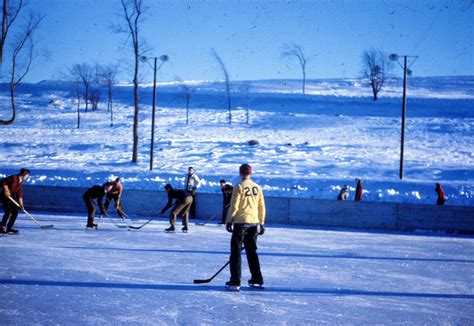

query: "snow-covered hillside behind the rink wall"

left=0, top=77, right=474, bottom=206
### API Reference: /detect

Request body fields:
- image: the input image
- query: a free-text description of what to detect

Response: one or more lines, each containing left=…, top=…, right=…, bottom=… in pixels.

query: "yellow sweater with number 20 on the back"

left=227, top=179, right=265, bottom=224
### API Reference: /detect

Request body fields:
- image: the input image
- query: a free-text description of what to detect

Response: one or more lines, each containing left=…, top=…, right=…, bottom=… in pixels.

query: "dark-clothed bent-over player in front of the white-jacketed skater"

left=160, top=184, right=193, bottom=233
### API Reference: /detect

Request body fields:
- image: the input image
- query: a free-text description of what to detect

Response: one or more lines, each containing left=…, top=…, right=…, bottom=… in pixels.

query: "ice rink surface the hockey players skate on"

left=0, top=212, right=474, bottom=325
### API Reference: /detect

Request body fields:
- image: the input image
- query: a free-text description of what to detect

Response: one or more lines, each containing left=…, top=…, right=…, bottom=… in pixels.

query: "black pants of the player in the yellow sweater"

left=230, top=224, right=263, bottom=284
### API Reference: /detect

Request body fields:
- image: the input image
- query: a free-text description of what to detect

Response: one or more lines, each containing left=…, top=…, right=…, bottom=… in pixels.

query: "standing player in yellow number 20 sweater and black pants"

left=225, top=164, right=265, bottom=291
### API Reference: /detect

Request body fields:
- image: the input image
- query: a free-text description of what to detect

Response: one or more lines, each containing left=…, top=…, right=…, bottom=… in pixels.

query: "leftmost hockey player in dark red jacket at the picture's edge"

left=0, top=169, right=30, bottom=234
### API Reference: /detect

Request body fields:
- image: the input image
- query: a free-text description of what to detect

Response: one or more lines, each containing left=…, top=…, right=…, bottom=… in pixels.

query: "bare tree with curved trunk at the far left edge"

left=0, top=10, right=44, bottom=125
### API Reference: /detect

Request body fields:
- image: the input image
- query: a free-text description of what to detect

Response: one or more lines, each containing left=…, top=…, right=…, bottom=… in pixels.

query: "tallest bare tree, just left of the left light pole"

left=113, top=0, right=145, bottom=163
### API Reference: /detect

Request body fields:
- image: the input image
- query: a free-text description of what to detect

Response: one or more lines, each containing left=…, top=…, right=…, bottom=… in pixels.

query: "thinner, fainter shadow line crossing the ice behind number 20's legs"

left=60, top=246, right=474, bottom=264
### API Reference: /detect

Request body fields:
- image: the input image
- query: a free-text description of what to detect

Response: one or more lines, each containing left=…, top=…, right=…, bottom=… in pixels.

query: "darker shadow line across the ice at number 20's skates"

left=0, top=279, right=474, bottom=300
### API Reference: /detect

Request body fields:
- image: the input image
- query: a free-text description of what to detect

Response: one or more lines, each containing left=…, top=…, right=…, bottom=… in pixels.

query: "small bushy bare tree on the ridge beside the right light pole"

left=362, top=50, right=392, bottom=101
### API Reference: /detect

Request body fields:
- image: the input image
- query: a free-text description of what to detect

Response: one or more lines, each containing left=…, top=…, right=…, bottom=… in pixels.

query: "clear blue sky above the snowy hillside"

left=10, top=0, right=474, bottom=82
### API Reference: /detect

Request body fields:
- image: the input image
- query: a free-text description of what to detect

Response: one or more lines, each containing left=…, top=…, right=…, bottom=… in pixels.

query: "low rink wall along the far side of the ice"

left=17, top=186, right=474, bottom=233
